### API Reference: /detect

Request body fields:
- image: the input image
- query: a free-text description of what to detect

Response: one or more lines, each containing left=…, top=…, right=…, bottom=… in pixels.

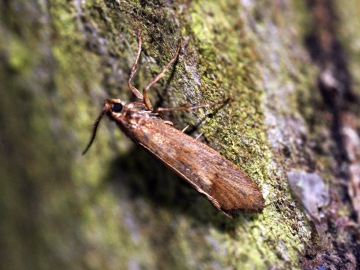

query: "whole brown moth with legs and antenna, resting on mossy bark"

left=83, top=34, right=264, bottom=217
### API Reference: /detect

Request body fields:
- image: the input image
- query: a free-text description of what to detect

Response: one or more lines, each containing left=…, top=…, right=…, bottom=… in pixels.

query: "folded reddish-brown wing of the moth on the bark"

left=133, top=119, right=264, bottom=216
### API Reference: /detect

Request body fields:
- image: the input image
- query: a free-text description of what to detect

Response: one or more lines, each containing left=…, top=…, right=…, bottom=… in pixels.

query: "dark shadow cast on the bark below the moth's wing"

left=90, top=146, right=258, bottom=233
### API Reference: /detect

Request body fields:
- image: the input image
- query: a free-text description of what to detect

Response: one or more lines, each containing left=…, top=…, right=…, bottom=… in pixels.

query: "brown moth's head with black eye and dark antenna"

left=83, top=99, right=124, bottom=155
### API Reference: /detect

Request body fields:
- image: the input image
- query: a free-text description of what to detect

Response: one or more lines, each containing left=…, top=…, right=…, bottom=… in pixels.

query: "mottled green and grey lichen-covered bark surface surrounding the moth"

left=0, top=0, right=360, bottom=269
